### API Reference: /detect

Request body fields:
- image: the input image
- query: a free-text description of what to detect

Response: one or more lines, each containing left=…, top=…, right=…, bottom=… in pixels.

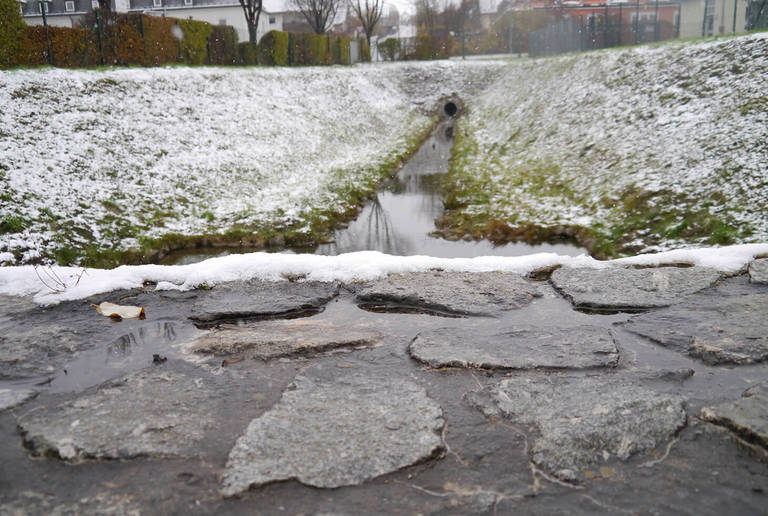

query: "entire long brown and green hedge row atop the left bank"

left=0, top=10, right=370, bottom=68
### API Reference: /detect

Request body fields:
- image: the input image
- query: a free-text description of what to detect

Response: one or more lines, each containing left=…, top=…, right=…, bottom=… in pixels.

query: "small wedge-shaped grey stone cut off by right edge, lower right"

left=701, top=382, right=768, bottom=449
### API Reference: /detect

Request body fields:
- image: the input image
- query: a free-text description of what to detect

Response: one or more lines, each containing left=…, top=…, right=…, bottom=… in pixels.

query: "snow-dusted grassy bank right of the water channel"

left=442, top=34, right=768, bottom=256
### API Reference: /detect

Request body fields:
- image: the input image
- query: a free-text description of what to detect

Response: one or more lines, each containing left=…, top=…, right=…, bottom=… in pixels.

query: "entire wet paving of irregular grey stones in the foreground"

left=0, top=269, right=768, bottom=515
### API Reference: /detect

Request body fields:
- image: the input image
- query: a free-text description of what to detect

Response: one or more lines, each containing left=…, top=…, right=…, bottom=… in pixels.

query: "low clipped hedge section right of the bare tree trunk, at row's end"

left=258, top=30, right=370, bottom=66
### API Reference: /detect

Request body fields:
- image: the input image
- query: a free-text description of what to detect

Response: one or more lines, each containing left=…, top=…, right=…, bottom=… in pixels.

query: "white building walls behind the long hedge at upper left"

left=21, top=0, right=286, bottom=41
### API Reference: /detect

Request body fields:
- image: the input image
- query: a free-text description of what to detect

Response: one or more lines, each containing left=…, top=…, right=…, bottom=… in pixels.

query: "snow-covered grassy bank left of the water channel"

left=0, top=63, right=499, bottom=266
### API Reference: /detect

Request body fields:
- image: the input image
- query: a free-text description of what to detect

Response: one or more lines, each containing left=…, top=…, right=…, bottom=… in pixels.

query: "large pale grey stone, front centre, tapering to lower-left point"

left=221, top=374, right=444, bottom=496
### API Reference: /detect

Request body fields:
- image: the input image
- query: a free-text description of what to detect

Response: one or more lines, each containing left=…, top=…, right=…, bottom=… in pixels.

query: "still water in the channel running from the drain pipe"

left=161, top=120, right=589, bottom=265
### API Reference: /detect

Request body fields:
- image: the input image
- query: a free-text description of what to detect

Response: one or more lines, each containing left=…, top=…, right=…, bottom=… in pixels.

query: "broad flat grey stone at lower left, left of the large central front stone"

left=19, top=367, right=217, bottom=461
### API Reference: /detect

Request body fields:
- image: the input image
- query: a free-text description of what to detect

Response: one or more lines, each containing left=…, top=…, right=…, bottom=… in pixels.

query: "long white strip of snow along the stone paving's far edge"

left=0, top=244, right=768, bottom=305
